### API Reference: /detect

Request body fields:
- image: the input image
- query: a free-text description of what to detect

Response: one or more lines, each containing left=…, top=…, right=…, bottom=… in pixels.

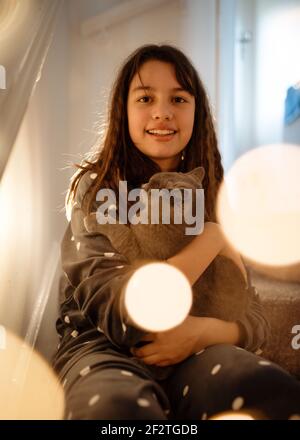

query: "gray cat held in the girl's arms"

left=85, top=167, right=248, bottom=380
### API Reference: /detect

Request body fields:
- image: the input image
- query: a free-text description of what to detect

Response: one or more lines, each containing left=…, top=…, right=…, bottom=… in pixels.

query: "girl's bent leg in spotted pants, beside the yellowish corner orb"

left=61, top=352, right=170, bottom=420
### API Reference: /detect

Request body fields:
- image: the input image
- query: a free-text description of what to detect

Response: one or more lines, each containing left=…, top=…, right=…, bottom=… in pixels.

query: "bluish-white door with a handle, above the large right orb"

left=217, top=0, right=300, bottom=171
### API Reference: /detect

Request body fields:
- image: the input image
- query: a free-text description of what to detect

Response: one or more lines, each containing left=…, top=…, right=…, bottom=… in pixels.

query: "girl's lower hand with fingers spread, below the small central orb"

left=130, top=315, right=209, bottom=367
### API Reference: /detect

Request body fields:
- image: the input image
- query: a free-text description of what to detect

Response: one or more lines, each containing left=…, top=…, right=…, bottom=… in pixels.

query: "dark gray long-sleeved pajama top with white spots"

left=53, top=171, right=270, bottom=373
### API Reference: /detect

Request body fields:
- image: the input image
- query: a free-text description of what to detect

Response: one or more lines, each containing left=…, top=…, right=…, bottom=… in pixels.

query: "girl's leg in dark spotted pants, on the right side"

left=160, top=344, right=300, bottom=420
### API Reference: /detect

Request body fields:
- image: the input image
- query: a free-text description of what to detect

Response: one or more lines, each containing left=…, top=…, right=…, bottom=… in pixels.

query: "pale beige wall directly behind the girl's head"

left=69, top=0, right=216, bottom=160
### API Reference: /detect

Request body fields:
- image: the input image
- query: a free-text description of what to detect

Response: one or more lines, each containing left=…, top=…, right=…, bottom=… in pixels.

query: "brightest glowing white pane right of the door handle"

left=254, top=0, right=300, bottom=145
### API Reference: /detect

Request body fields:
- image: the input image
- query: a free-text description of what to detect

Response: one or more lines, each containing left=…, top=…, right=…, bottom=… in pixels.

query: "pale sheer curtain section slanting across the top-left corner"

left=0, top=0, right=63, bottom=179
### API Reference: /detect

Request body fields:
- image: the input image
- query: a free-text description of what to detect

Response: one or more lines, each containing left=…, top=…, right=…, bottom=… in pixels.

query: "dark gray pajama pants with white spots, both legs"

left=61, top=344, right=300, bottom=420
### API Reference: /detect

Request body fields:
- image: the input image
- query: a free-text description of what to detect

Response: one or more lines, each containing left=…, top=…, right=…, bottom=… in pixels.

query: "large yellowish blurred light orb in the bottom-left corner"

left=0, top=326, right=65, bottom=420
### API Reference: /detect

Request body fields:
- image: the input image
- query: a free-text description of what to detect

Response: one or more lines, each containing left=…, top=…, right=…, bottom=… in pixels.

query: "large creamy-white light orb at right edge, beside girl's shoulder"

left=217, top=144, right=300, bottom=266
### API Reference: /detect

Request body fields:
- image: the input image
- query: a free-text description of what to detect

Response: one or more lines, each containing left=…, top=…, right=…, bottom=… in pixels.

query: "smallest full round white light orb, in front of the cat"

left=125, top=263, right=192, bottom=331
